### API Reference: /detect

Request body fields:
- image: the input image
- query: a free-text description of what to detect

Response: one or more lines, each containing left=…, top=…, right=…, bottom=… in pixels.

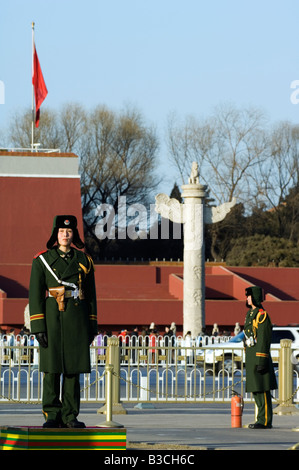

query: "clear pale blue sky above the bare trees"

left=0, top=0, right=299, bottom=192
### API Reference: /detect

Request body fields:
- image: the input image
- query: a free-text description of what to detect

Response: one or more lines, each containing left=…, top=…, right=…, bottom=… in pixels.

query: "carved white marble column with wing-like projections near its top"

left=155, top=162, right=236, bottom=338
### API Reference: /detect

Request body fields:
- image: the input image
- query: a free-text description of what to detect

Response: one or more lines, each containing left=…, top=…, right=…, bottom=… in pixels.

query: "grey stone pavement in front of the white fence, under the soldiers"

left=0, top=403, right=299, bottom=450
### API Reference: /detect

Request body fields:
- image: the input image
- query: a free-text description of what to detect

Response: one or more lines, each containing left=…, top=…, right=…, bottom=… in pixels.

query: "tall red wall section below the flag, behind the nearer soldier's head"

left=0, top=177, right=83, bottom=264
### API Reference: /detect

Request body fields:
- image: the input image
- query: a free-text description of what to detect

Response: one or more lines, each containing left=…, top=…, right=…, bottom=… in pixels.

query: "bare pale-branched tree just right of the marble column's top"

left=206, top=106, right=267, bottom=204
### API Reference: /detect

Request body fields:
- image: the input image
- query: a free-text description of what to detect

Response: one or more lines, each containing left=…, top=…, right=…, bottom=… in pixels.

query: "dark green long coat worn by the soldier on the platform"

left=29, top=247, right=97, bottom=374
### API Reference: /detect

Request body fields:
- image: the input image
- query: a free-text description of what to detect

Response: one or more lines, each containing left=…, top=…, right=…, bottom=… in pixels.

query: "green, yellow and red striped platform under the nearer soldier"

left=0, top=426, right=126, bottom=450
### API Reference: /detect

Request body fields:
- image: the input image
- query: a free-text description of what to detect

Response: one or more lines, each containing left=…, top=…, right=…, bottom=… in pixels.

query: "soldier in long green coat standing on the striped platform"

left=29, top=215, right=97, bottom=428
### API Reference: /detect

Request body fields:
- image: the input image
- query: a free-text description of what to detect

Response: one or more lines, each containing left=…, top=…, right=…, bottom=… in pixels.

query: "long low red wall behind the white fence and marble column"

left=0, top=263, right=299, bottom=332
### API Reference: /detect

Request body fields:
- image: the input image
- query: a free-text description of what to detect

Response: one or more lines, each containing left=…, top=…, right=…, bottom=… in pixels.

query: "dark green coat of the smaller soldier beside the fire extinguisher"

left=244, top=308, right=277, bottom=392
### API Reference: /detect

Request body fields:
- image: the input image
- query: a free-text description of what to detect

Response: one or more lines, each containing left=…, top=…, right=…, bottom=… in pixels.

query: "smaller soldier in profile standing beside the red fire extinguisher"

left=244, top=286, right=277, bottom=429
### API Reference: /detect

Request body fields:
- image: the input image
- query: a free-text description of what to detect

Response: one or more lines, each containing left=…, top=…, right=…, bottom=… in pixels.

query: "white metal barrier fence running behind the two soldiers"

left=0, top=335, right=299, bottom=403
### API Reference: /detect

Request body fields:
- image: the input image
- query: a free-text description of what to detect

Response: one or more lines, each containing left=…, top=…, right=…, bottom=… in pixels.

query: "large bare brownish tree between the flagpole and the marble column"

left=81, top=106, right=159, bottom=252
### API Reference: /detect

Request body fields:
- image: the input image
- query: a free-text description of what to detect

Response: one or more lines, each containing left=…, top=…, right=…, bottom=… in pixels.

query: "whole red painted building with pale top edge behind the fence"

left=0, top=152, right=299, bottom=333
